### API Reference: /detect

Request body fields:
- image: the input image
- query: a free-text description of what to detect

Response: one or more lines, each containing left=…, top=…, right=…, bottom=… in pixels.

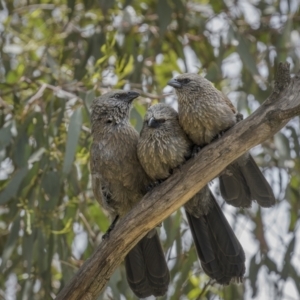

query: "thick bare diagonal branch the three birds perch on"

left=57, top=64, right=300, bottom=300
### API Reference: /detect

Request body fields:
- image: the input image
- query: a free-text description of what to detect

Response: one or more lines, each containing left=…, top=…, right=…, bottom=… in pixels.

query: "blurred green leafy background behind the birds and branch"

left=0, top=0, right=300, bottom=300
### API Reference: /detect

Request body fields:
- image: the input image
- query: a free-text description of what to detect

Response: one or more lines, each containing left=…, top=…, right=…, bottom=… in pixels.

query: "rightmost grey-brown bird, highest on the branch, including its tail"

left=168, top=73, right=275, bottom=207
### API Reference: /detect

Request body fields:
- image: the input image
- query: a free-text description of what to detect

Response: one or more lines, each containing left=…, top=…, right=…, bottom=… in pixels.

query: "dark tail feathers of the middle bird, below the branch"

left=186, top=193, right=245, bottom=284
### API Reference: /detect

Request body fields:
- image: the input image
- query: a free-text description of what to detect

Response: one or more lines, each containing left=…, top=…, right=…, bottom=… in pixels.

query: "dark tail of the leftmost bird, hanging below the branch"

left=125, top=229, right=170, bottom=298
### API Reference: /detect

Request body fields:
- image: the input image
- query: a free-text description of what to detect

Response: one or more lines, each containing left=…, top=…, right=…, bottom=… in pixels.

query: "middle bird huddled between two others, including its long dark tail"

left=137, top=103, right=245, bottom=284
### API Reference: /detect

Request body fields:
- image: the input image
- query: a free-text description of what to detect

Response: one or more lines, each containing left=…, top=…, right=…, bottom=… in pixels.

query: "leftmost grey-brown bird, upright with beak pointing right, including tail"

left=90, top=90, right=170, bottom=298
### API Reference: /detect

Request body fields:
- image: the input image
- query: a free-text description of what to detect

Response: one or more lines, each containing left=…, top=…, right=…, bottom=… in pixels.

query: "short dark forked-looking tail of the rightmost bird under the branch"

left=220, top=154, right=275, bottom=207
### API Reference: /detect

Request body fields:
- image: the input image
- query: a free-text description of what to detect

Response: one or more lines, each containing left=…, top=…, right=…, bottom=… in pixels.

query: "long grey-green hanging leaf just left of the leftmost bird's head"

left=63, top=107, right=82, bottom=174
